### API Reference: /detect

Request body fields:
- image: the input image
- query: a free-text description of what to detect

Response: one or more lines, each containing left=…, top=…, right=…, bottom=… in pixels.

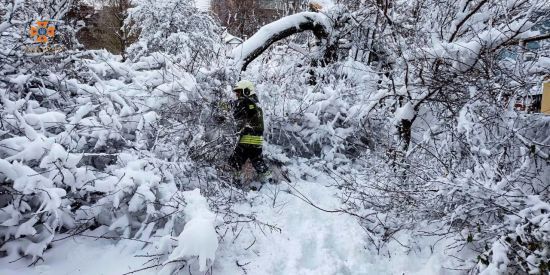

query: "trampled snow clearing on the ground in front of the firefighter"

left=214, top=162, right=460, bottom=275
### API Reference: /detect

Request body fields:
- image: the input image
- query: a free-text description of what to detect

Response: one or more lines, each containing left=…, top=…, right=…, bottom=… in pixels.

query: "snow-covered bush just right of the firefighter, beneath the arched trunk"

left=259, top=60, right=378, bottom=160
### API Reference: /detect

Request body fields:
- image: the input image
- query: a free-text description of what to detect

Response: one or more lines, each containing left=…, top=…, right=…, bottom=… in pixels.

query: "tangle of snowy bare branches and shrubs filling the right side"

left=328, top=1, right=550, bottom=272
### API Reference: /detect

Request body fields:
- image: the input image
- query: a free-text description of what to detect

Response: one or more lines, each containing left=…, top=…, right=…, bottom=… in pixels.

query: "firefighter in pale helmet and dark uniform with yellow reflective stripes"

left=229, top=80, right=272, bottom=189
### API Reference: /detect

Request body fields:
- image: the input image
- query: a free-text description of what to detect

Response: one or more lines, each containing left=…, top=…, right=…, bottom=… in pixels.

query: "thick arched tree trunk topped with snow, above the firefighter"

left=232, top=12, right=332, bottom=71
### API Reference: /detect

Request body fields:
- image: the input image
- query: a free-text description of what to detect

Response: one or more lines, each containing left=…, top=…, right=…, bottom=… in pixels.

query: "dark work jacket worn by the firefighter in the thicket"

left=233, top=95, right=264, bottom=136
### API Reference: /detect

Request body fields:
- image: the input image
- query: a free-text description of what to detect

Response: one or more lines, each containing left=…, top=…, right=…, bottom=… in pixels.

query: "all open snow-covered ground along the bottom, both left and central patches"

left=0, top=165, right=462, bottom=275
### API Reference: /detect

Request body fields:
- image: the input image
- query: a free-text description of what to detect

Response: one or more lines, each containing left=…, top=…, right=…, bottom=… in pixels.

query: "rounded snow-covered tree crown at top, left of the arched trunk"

left=126, top=0, right=223, bottom=71
